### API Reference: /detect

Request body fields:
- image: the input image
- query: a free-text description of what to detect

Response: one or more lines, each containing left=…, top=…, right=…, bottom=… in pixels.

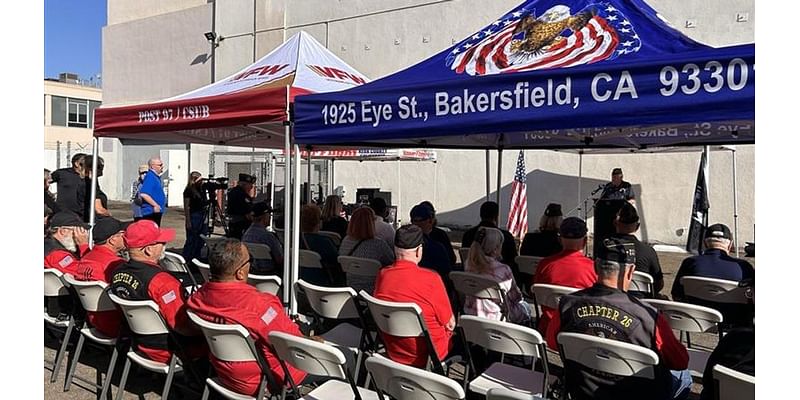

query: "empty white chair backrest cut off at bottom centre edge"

left=366, top=356, right=465, bottom=400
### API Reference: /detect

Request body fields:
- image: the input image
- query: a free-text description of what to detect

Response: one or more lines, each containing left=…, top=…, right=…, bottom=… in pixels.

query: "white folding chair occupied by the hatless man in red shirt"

left=186, top=311, right=279, bottom=400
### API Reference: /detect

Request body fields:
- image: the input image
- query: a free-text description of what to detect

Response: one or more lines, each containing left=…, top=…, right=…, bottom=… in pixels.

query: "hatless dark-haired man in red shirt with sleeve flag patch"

left=186, top=239, right=306, bottom=396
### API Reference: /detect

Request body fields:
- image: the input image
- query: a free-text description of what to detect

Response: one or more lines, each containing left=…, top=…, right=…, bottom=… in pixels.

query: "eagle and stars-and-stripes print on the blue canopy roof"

left=446, top=2, right=642, bottom=76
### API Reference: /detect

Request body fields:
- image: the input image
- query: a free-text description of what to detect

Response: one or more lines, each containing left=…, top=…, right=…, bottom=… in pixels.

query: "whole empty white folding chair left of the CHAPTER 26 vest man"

left=458, top=315, right=550, bottom=397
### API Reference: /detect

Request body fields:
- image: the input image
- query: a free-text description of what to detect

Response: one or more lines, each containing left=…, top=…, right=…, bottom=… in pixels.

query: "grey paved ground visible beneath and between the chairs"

left=44, top=202, right=755, bottom=400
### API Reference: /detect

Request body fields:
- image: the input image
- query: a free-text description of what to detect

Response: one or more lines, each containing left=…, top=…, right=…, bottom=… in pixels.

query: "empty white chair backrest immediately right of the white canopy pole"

left=294, top=279, right=359, bottom=319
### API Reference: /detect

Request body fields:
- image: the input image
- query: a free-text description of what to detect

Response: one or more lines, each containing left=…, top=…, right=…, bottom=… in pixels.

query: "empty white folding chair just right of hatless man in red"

left=269, top=332, right=378, bottom=400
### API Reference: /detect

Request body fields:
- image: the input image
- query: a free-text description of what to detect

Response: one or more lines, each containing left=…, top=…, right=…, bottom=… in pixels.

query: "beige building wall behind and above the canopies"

left=103, top=0, right=755, bottom=244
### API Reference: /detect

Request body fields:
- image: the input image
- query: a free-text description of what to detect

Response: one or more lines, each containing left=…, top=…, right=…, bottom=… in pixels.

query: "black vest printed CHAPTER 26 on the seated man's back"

left=559, top=283, right=672, bottom=400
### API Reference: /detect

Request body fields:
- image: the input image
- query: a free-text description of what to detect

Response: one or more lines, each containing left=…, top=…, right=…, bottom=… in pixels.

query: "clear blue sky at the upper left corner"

left=44, top=0, right=106, bottom=79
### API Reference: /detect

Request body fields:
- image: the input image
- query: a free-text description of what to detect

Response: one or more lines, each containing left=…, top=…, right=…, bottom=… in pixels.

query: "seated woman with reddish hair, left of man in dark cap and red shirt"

left=339, top=207, right=394, bottom=294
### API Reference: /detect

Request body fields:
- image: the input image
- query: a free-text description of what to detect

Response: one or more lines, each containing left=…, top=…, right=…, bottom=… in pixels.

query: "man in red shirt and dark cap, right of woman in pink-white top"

left=533, top=217, right=597, bottom=332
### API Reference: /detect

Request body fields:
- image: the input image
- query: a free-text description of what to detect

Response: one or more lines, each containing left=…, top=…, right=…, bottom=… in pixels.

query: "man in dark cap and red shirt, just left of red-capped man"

left=73, top=217, right=129, bottom=337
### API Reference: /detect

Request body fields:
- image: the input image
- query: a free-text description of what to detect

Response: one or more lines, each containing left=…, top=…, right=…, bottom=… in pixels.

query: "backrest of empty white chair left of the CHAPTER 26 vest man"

left=458, top=315, right=545, bottom=360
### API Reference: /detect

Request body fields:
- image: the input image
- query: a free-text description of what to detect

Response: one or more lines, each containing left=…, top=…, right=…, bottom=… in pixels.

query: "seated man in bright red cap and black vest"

left=109, top=219, right=207, bottom=363
